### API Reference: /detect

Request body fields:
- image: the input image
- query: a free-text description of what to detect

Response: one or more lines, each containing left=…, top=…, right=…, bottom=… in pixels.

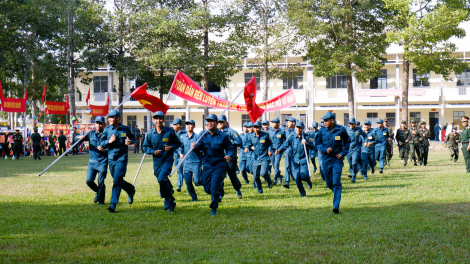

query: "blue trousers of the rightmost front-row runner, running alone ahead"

left=322, top=156, right=344, bottom=209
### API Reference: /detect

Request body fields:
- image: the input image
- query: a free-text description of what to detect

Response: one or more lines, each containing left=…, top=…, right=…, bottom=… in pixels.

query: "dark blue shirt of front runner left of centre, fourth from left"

left=194, top=129, right=235, bottom=166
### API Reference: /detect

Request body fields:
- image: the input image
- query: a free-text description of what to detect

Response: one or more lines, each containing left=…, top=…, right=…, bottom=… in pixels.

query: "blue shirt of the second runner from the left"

left=100, top=125, right=135, bottom=161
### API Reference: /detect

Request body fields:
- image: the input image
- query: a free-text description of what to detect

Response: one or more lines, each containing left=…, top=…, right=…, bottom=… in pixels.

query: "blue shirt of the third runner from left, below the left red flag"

left=142, top=127, right=181, bottom=164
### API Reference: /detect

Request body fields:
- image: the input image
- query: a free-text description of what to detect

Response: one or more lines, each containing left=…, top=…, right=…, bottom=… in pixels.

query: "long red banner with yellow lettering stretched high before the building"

left=170, top=71, right=295, bottom=112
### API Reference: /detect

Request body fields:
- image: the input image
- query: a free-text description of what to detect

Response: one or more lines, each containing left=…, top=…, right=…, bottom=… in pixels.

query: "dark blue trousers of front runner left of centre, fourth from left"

left=202, top=163, right=226, bottom=209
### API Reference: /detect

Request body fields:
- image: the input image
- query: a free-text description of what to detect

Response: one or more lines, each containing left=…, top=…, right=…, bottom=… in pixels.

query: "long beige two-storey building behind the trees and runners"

left=76, top=52, right=470, bottom=138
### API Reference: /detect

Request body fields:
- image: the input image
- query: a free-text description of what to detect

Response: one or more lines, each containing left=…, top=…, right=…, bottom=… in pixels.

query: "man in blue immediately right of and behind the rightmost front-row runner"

left=346, top=118, right=365, bottom=182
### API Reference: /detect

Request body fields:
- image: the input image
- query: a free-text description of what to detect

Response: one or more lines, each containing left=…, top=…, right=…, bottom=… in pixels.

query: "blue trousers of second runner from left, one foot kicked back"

left=109, top=160, right=135, bottom=205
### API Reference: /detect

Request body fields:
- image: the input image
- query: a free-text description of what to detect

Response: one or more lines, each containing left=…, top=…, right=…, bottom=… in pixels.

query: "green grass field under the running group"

left=0, top=149, right=470, bottom=263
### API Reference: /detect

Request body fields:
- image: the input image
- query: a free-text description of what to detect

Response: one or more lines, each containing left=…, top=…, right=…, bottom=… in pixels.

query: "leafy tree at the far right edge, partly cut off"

left=384, top=0, right=469, bottom=121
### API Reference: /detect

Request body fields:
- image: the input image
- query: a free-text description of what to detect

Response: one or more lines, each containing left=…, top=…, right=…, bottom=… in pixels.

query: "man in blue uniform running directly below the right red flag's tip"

left=244, top=121, right=273, bottom=193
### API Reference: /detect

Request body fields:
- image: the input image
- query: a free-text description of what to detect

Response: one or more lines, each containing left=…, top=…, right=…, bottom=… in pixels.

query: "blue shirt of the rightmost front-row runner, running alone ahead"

left=315, top=124, right=351, bottom=158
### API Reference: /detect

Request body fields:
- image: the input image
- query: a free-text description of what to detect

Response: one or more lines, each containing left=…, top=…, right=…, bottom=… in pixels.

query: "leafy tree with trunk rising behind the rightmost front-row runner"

left=288, top=0, right=392, bottom=117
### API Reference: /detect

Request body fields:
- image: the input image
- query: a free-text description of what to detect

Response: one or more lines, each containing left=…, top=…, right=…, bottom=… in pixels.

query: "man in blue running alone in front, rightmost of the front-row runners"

left=315, top=112, right=351, bottom=214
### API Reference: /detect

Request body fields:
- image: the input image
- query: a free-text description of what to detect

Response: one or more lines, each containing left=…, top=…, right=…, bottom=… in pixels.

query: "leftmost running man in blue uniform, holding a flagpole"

left=78, top=116, right=108, bottom=205
